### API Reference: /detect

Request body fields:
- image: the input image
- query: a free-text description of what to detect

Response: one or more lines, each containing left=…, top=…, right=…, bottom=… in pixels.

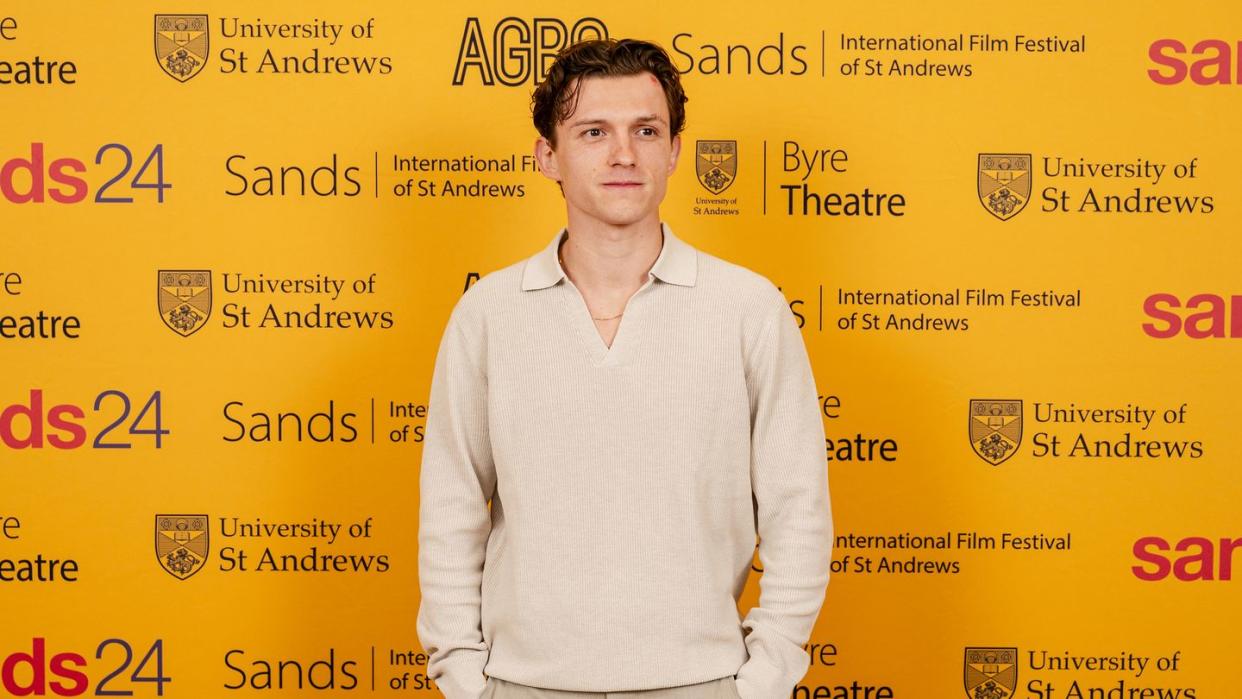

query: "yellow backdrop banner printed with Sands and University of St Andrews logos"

left=0, top=1, right=1242, bottom=699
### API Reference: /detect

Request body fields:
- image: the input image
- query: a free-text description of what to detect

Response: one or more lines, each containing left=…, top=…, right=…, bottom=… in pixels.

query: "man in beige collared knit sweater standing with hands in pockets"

left=417, top=40, right=832, bottom=699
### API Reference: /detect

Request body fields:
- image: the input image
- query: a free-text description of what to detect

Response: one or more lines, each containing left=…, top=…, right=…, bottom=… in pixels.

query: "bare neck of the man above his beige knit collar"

left=560, top=216, right=664, bottom=291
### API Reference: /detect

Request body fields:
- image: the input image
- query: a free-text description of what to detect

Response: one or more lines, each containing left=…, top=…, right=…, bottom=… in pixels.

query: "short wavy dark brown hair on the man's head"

left=530, top=38, right=688, bottom=145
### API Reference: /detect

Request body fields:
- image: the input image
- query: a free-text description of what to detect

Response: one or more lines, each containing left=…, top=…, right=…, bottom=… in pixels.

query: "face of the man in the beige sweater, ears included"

left=535, top=73, right=682, bottom=232
